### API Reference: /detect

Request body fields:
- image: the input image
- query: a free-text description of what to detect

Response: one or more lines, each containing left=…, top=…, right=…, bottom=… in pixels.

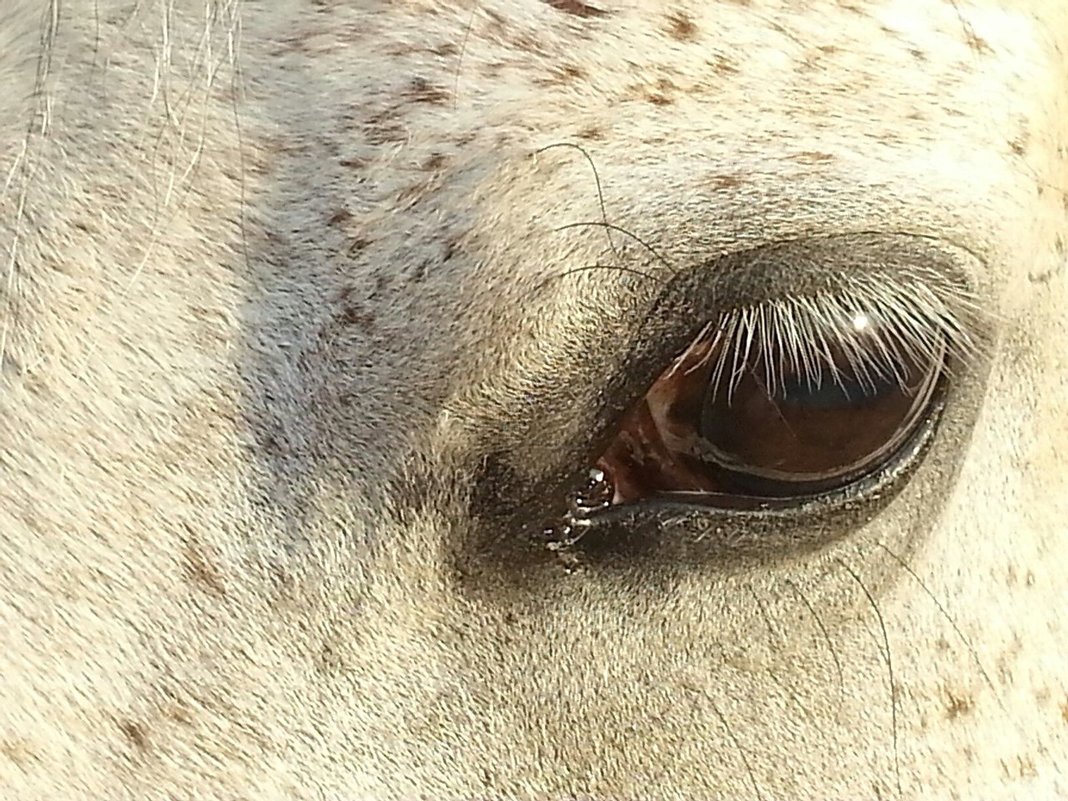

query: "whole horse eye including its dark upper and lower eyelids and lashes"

left=529, top=235, right=991, bottom=565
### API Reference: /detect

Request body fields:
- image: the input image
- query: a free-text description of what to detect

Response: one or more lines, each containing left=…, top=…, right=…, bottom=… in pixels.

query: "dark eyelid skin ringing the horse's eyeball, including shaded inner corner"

left=455, top=233, right=996, bottom=581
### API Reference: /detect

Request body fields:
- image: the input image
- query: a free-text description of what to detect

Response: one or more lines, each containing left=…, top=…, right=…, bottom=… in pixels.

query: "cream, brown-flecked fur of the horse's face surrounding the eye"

left=0, top=0, right=1068, bottom=801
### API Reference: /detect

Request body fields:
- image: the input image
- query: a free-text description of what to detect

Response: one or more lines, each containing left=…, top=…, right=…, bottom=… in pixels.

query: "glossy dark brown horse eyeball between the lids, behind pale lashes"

left=586, top=307, right=947, bottom=508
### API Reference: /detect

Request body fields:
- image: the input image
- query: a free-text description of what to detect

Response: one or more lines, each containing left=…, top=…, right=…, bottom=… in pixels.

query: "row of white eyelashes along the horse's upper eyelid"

left=673, top=277, right=979, bottom=403
